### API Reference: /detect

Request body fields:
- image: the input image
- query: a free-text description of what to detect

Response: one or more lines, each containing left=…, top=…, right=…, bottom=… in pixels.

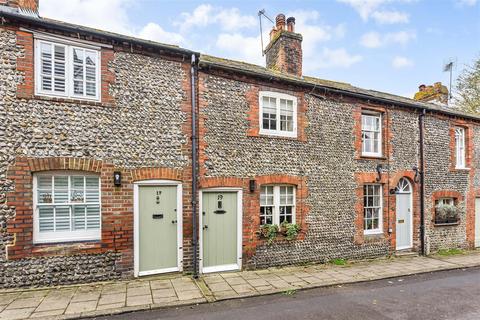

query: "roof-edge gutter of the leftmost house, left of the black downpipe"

left=0, top=5, right=200, bottom=58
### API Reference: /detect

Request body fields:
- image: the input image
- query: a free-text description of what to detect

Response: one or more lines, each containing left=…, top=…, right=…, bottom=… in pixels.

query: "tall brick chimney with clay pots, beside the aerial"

left=265, top=14, right=302, bottom=77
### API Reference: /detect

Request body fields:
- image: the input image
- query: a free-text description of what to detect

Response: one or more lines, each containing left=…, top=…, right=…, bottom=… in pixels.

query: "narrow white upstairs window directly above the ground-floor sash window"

left=362, top=113, right=382, bottom=157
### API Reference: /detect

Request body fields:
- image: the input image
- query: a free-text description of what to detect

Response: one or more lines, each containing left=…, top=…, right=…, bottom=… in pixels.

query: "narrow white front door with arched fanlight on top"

left=396, top=178, right=413, bottom=250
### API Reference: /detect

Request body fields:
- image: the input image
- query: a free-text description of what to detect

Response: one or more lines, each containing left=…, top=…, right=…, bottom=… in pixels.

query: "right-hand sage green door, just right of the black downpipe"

left=202, top=192, right=238, bottom=272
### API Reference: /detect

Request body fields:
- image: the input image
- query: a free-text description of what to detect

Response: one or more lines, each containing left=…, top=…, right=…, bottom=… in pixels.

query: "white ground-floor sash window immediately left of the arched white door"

left=363, top=184, right=383, bottom=234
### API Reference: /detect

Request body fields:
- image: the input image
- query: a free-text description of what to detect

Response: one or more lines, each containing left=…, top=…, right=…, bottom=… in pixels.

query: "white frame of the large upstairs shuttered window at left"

left=34, top=35, right=102, bottom=102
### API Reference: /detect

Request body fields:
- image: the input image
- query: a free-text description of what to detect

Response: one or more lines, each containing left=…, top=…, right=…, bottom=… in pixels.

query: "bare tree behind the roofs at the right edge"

left=455, top=58, right=480, bottom=114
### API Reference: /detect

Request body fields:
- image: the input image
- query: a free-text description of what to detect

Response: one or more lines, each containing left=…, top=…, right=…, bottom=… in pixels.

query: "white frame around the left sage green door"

left=133, top=180, right=183, bottom=277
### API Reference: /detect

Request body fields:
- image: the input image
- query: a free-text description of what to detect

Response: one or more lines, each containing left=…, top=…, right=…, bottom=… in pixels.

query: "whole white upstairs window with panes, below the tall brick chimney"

left=259, top=91, right=297, bottom=137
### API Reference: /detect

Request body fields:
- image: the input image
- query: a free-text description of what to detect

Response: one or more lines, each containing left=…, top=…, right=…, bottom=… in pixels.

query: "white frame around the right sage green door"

left=198, top=187, right=243, bottom=273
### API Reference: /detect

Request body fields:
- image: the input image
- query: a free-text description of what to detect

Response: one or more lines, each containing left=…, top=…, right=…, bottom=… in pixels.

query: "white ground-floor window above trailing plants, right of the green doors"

left=260, top=185, right=295, bottom=225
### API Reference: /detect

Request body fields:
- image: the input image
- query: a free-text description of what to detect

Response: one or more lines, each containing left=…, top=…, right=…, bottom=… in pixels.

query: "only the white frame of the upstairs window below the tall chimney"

left=258, top=91, right=297, bottom=138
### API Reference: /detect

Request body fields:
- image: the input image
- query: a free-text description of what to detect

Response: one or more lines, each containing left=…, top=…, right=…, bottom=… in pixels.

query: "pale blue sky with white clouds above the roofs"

left=40, top=0, right=480, bottom=98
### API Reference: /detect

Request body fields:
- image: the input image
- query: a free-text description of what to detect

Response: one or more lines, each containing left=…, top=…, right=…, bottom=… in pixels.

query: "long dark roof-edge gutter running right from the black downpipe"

left=199, top=61, right=480, bottom=121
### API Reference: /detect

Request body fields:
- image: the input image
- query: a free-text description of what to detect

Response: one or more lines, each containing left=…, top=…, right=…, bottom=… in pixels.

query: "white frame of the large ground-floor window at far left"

left=33, top=170, right=102, bottom=244
